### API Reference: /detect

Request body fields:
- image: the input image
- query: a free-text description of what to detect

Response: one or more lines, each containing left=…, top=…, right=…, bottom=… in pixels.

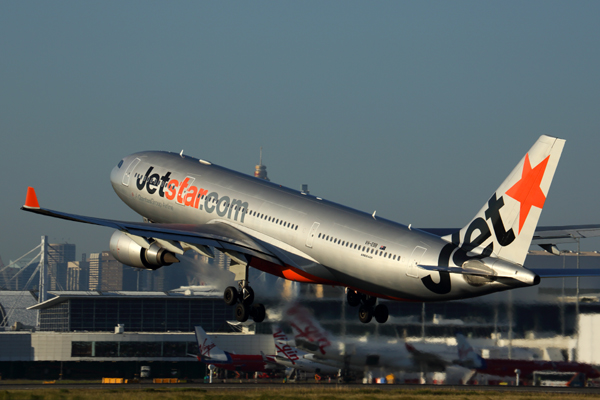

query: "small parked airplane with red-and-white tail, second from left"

left=265, top=325, right=344, bottom=375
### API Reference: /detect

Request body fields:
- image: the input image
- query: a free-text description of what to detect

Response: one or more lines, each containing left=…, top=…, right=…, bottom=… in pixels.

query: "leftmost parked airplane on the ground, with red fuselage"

left=195, top=326, right=283, bottom=372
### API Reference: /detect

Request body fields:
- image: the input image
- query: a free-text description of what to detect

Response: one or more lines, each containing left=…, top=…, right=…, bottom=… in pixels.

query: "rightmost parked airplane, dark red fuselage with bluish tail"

left=455, top=333, right=600, bottom=380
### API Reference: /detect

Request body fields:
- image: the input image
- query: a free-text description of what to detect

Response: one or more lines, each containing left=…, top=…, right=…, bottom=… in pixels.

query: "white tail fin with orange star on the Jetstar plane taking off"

left=444, top=135, right=565, bottom=265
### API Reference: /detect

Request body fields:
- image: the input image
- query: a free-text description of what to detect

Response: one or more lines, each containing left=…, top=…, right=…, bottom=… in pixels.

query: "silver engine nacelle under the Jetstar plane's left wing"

left=110, top=231, right=179, bottom=270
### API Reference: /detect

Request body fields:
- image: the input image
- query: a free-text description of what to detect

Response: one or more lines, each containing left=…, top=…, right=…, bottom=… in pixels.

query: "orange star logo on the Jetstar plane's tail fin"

left=506, top=154, right=550, bottom=233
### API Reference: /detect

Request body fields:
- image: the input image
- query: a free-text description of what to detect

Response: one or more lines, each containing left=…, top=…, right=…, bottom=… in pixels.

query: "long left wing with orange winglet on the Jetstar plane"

left=21, top=188, right=288, bottom=266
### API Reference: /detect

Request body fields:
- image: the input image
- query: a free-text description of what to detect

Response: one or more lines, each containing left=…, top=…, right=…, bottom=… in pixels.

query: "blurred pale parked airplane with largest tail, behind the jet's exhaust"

left=284, top=303, right=452, bottom=372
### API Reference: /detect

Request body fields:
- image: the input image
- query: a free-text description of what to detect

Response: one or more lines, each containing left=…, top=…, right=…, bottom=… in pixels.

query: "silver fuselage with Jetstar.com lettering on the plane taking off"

left=111, top=151, right=532, bottom=301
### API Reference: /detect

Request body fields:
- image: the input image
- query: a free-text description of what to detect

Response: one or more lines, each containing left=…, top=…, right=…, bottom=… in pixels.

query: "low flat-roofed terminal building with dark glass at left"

left=0, top=290, right=274, bottom=379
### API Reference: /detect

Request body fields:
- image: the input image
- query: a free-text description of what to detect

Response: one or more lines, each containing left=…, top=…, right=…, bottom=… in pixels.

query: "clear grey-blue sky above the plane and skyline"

left=0, top=1, right=600, bottom=263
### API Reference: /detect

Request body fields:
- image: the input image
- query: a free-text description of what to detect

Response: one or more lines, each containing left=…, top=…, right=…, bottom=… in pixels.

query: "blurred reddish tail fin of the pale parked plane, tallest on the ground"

left=285, top=303, right=332, bottom=355
